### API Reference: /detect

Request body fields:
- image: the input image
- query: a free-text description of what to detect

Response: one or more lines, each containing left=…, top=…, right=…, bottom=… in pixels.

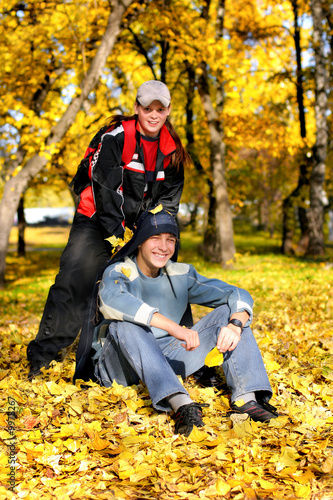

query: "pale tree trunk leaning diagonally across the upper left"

left=0, top=0, right=133, bottom=287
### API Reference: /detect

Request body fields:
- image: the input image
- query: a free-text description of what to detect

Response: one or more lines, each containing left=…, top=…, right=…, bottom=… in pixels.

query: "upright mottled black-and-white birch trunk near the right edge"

left=307, top=0, right=328, bottom=256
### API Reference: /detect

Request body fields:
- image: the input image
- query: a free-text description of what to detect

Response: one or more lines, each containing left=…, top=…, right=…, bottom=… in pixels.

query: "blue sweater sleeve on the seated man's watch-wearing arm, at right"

left=188, top=266, right=253, bottom=326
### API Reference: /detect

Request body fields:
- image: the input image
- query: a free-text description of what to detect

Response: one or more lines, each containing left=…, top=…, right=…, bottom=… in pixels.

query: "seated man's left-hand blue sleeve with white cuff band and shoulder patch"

left=99, top=261, right=158, bottom=326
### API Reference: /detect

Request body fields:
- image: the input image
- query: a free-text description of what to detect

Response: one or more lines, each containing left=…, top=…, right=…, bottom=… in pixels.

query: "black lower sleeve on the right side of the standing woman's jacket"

left=156, top=160, right=184, bottom=217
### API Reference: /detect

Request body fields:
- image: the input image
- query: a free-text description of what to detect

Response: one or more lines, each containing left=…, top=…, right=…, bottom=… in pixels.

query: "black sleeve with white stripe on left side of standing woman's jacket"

left=92, top=133, right=125, bottom=237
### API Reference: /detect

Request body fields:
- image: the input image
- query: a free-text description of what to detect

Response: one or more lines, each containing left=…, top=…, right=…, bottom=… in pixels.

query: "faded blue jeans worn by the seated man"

left=95, top=305, right=272, bottom=411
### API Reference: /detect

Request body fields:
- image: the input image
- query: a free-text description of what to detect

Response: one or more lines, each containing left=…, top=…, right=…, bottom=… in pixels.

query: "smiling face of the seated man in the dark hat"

left=136, top=233, right=177, bottom=278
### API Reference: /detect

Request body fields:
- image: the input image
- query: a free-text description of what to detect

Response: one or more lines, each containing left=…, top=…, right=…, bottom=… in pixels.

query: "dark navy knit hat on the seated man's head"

left=110, top=205, right=179, bottom=264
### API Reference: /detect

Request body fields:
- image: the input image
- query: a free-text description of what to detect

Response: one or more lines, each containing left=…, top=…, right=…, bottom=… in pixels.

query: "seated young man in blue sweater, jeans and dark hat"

left=76, top=206, right=278, bottom=436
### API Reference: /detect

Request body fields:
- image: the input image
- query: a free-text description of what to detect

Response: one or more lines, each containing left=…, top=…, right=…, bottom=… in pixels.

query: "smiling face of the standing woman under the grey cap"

left=134, top=101, right=170, bottom=137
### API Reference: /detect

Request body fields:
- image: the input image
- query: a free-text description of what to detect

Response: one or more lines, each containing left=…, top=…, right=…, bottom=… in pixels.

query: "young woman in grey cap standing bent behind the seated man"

left=27, top=80, right=190, bottom=377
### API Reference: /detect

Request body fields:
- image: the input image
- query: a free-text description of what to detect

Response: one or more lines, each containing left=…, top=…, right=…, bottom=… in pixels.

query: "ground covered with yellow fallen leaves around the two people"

left=0, top=231, right=333, bottom=500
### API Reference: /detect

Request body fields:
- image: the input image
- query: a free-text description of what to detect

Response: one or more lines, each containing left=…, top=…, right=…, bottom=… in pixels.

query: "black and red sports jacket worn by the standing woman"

left=70, top=120, right=184, bottom=237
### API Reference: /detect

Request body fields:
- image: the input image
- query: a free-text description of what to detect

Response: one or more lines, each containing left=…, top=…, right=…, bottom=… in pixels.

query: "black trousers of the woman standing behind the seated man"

left=27, top=213, right=111, bottom=363
